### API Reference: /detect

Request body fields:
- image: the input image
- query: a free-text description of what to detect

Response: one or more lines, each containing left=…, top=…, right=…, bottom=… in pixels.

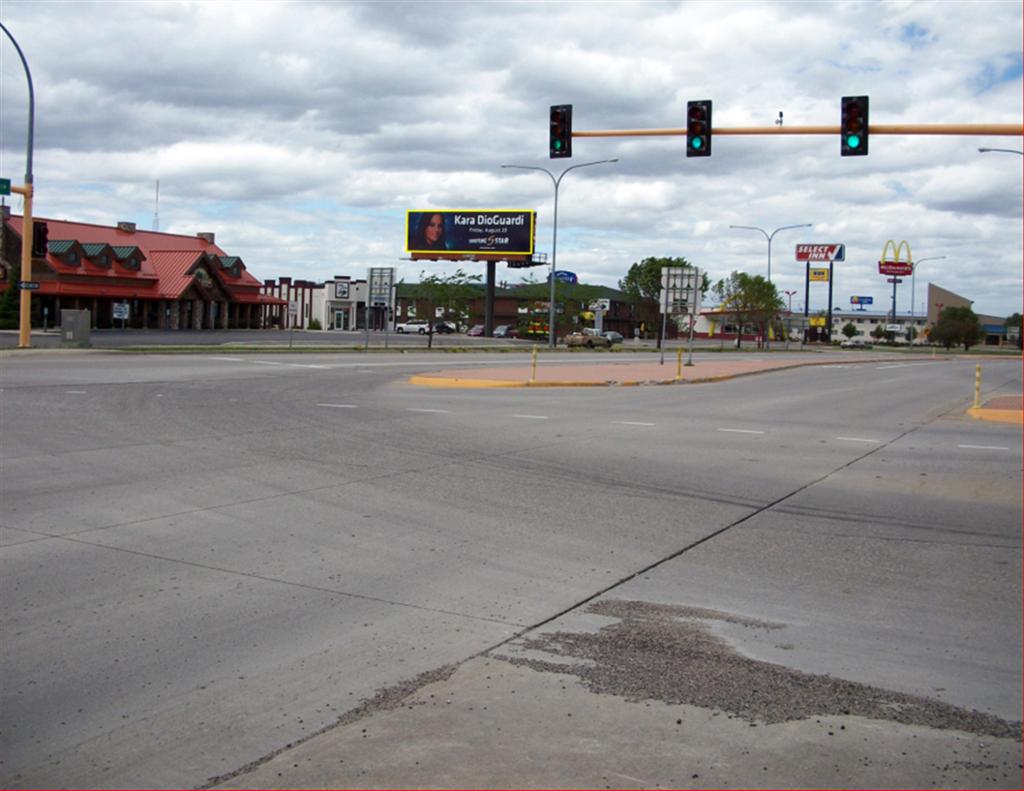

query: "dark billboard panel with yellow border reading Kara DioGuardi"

left=406, top=209, right=537, bottom=255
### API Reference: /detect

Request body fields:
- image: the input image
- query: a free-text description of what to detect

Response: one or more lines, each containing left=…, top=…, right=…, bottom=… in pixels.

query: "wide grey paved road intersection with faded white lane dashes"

left=0, top=351, right=1021, bottom=788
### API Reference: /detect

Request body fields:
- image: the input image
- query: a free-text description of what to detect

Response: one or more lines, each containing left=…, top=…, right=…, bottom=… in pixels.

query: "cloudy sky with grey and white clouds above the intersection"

left=0, top=0, right=1024, bottom=315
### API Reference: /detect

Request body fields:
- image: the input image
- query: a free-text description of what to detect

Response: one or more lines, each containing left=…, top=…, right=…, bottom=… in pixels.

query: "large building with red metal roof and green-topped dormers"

left=0, top=207, right=288, bottom=330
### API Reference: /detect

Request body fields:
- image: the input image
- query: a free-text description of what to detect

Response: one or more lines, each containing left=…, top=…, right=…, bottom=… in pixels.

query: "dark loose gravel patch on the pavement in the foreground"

left=505, top=599, right=1021, bottom=741
